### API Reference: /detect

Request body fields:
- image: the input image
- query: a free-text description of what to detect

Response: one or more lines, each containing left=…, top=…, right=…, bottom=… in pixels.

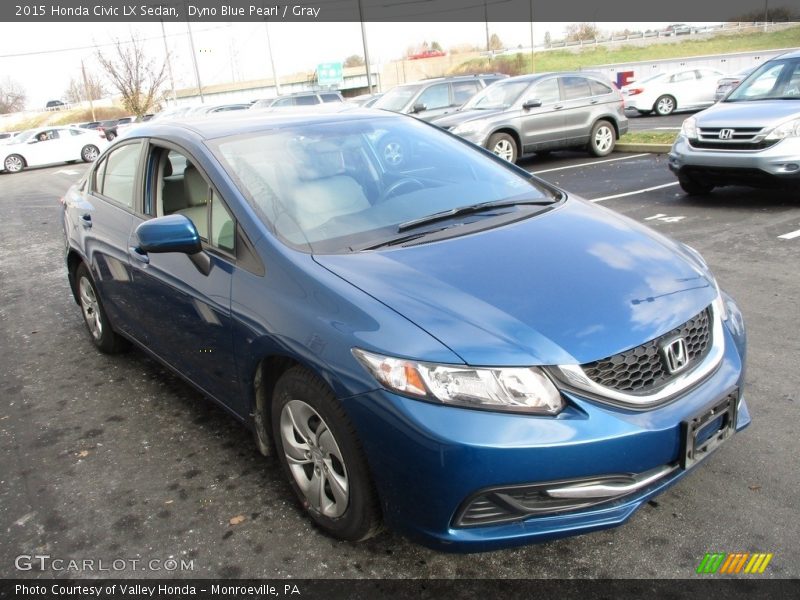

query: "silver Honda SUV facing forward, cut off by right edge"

left=669, top=51, right=800, bottom=195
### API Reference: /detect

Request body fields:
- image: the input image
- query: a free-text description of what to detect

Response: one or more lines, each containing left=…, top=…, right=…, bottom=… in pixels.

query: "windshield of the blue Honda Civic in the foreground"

left=214, top=117, right=556, bottom=253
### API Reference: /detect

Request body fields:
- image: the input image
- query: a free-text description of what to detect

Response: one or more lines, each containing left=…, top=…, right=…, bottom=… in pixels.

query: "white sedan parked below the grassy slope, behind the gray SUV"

left=622, top=67, right=724, bottom=116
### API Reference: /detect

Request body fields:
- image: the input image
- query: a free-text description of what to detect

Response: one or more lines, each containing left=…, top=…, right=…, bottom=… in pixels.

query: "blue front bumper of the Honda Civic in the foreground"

left=343, top=312, right=750, bottom=552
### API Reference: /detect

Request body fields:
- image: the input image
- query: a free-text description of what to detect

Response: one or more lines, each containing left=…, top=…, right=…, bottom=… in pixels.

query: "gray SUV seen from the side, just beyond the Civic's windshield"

left=431, top=72, right=628, bottom=162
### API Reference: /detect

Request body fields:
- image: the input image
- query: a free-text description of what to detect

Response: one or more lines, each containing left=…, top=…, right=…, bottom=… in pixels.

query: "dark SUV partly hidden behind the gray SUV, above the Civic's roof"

left=372, top=73, right=508, bottom=121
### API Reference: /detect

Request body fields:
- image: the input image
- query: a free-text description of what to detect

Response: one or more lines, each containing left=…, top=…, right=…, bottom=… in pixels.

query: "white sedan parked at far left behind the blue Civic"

left=0, top=126, right=108, bottom=173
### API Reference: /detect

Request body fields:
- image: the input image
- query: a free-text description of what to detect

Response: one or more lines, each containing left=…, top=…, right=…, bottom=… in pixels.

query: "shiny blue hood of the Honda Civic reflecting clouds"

left=314, top=199, right=716, bottom=366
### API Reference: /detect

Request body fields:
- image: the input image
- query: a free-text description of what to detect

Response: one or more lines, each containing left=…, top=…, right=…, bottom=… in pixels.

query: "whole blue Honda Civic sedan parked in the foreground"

left=64, top=109, right=750, bottom=551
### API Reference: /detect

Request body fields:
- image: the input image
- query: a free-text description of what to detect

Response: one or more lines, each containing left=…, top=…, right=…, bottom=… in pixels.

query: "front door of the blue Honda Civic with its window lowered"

left=129, top=142, right=239, bottom=404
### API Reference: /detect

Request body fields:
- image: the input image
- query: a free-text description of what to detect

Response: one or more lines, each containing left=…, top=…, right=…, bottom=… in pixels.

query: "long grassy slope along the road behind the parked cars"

left=450, top=26, right=800, bottom=75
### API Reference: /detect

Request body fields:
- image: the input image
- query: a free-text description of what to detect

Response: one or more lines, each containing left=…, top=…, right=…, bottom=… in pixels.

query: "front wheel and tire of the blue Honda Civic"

left=272, top=366, right=381, bottom=542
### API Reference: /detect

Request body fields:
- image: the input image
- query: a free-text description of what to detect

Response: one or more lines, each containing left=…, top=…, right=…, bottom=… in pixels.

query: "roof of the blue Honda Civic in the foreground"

left=119, top=103, right=400, bottom=140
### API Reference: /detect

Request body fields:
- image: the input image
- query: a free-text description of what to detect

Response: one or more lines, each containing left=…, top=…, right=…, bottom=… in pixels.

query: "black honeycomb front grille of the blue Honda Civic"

left=581, top=308, right=711, bottom=394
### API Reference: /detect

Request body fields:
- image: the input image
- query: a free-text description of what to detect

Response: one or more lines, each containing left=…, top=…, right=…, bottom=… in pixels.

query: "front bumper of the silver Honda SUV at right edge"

left=668, top=135, right=800, bottom=186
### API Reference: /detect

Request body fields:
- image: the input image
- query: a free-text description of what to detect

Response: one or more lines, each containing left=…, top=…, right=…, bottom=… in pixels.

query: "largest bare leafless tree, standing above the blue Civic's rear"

left=97, top=36, right=167, bottom=116
